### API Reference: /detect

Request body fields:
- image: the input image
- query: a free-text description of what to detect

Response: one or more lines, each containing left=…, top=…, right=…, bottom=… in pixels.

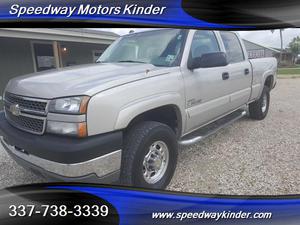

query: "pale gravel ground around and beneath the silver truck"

left=0, top=79, right=300, bottom=195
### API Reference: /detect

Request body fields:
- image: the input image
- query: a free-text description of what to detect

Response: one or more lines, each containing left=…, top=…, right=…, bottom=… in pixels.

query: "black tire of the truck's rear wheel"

left=249, top=86, right=270, bottom=120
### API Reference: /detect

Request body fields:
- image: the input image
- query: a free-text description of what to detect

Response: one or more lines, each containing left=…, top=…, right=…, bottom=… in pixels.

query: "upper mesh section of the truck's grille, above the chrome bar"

left=4, top=92, right=47, bottom=113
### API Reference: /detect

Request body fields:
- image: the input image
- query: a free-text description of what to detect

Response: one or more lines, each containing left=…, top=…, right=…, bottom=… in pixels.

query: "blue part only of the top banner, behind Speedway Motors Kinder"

left=0, top=0, right=239, bottom=28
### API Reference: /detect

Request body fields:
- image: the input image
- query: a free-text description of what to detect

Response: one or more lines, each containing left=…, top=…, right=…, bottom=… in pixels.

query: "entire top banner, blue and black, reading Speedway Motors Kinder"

left=0, top=0, right=300, bottom=29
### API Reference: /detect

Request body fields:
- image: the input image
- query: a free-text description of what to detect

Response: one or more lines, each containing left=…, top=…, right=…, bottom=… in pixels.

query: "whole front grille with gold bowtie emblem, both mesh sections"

left=4, top=92, right=48, bottom=135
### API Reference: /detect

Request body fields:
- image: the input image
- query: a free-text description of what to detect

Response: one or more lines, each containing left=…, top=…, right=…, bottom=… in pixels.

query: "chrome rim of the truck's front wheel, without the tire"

left=143, top=141, right=169, bottom=184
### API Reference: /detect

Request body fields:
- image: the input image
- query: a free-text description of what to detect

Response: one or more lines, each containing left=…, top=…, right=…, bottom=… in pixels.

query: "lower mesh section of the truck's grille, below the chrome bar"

left=5, top=109, right=46, bottom=134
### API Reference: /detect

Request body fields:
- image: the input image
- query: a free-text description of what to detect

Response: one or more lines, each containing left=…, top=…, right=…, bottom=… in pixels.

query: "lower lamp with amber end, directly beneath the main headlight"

left=47, top=121, right=87, bottom=137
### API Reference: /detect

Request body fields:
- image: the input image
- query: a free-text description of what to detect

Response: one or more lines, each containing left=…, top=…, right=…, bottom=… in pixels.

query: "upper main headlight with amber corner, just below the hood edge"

left=49, top=96, right=90, bottom=114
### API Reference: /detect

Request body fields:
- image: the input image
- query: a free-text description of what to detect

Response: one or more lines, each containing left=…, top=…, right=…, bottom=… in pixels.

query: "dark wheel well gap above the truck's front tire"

left=127, top=105, right=182, bottom=137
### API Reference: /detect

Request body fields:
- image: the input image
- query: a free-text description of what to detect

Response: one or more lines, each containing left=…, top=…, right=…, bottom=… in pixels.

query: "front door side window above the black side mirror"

left=191, top=30, right=220, bottom=58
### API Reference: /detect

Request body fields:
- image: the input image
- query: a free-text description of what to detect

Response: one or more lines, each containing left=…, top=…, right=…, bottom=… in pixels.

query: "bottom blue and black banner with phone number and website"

left=0, top=183, right=300, bottom=225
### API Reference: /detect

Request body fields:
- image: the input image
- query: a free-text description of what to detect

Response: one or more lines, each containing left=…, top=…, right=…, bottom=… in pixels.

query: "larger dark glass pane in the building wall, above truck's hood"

left=32, top=42, right=57, bottom=72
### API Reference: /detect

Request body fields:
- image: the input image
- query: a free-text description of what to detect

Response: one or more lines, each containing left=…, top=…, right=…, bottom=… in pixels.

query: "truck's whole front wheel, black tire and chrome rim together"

left=120, top=121, right=178, bottom=189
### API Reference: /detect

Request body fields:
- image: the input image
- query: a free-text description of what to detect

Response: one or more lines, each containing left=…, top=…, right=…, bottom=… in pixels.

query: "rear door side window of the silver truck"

left=220, top=31, right=244, bottom=63
